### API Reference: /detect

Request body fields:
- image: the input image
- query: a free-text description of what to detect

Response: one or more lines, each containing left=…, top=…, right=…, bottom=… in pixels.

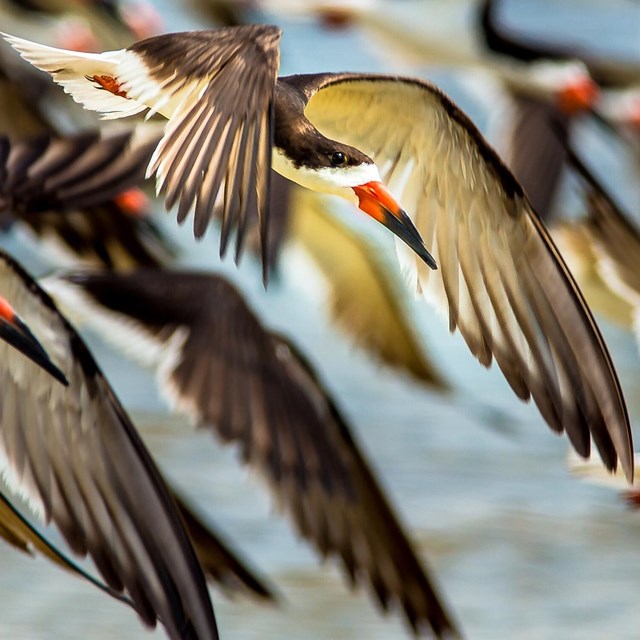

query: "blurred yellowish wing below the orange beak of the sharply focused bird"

left=291, top=189, right=447, bottom=389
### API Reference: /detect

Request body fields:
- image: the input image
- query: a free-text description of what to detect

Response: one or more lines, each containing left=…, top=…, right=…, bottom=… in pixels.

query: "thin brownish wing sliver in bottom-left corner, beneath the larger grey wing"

left=0, top=493, right=131, bottom=605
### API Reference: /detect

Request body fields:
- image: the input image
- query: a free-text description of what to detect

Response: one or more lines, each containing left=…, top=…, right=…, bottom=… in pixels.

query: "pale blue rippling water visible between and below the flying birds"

left=0, top=0, right=640, bottom=640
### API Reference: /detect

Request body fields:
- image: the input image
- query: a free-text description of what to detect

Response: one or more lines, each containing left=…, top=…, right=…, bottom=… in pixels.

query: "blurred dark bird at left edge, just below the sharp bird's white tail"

left=0, top=131, right=175, bottom=270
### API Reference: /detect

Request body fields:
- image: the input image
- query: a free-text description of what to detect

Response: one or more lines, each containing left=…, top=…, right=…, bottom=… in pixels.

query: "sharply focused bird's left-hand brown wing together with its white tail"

left=6, top=25, right=281, bottom=276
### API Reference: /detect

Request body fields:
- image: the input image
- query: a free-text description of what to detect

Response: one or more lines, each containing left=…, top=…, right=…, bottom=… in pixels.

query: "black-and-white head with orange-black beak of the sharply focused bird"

left=274, top=137, right=437, bottom=269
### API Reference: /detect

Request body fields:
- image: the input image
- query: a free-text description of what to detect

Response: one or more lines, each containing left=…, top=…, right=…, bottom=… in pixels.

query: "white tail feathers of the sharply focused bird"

left=1, top=33, right=147, bottom=119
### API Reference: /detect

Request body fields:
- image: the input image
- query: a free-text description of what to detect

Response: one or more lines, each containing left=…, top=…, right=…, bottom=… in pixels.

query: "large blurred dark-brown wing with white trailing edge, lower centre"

left=47, top=270, right=458, bottom=637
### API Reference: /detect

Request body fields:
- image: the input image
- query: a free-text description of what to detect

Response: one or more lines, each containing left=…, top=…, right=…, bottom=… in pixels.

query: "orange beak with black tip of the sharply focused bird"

left=353, top=182, right=438, bottom=269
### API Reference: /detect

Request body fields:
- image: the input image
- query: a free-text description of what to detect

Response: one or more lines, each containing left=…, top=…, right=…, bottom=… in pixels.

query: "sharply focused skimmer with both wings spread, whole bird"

left=4, top=25, right=633, bottom=481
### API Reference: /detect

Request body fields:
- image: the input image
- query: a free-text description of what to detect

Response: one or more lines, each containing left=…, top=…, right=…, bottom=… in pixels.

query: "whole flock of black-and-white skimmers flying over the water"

left=0, top=0, right=640, bottom=639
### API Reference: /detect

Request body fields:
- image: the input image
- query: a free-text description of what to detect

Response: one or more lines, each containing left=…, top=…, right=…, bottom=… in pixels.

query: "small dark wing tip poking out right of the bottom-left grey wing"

left=173, top=491, right=276, bottom=602
